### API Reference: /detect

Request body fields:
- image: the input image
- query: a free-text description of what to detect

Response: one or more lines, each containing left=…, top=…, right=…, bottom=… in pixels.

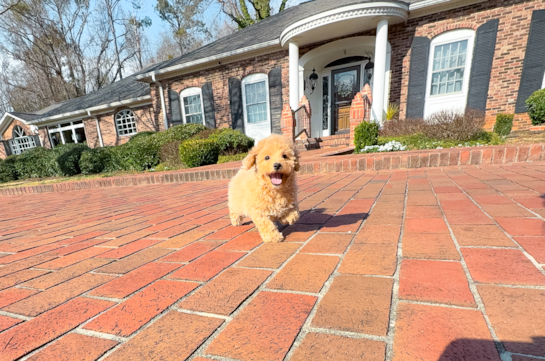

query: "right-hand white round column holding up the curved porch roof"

left=371, top=19, right=388, bottom=124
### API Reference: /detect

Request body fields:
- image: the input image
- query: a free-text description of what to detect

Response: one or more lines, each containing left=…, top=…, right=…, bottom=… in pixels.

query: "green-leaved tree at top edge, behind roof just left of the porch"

left=218, top=0, right=288, bottom=29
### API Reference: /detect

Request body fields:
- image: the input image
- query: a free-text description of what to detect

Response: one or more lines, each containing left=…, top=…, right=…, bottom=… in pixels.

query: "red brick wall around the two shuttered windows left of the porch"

left=157, top=50, right=289, bottom=128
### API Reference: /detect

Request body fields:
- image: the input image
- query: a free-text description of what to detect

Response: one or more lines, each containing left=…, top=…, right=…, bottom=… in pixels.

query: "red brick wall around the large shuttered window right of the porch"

left=388, top=0, right=545, bottom=130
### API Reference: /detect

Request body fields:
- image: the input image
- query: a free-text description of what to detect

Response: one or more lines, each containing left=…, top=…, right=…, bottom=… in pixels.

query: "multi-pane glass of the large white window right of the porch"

left=431, top=40, right=468, bottom=95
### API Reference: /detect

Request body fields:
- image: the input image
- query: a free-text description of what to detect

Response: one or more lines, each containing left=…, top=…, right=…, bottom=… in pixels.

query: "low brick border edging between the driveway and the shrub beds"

left=0, top=144, right=545, bottom=196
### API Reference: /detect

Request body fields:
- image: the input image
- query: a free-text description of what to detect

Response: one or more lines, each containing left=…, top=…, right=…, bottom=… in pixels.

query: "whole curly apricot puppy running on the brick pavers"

left=229, top=134, right=299, bottom=242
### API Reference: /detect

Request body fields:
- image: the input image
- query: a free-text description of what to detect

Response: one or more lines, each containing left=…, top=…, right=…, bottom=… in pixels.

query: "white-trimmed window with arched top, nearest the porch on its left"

left=242, top=74, right=270, bottom=124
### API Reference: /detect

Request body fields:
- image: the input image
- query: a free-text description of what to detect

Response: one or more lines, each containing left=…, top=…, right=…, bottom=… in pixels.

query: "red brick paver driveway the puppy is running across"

left=0, top=162, right=545, bottom=361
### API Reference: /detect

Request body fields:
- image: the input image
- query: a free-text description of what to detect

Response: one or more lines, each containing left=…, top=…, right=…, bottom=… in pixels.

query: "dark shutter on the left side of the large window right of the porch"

left=406, top=36, right=430, bottom=118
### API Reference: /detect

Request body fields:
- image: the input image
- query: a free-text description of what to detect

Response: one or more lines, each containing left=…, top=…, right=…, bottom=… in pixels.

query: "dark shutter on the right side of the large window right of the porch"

left=467, top=19, right=500, bottom=112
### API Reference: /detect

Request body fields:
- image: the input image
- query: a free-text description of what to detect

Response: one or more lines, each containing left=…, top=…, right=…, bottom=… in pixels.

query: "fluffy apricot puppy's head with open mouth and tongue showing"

left=243, top=134, right=299, bottom=187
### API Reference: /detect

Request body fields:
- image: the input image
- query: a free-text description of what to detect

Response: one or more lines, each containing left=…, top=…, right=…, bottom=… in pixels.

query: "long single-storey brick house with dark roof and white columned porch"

left=0, top=0, right=545, bottom=157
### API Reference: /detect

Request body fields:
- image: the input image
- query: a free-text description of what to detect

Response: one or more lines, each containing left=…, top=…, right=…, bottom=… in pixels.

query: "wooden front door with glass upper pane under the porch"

left=331, top=65, right=361, bottom=135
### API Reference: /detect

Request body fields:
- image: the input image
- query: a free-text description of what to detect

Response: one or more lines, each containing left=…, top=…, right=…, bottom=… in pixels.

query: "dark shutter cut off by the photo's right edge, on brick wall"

left=515, top=10, right=545, bottom=113
